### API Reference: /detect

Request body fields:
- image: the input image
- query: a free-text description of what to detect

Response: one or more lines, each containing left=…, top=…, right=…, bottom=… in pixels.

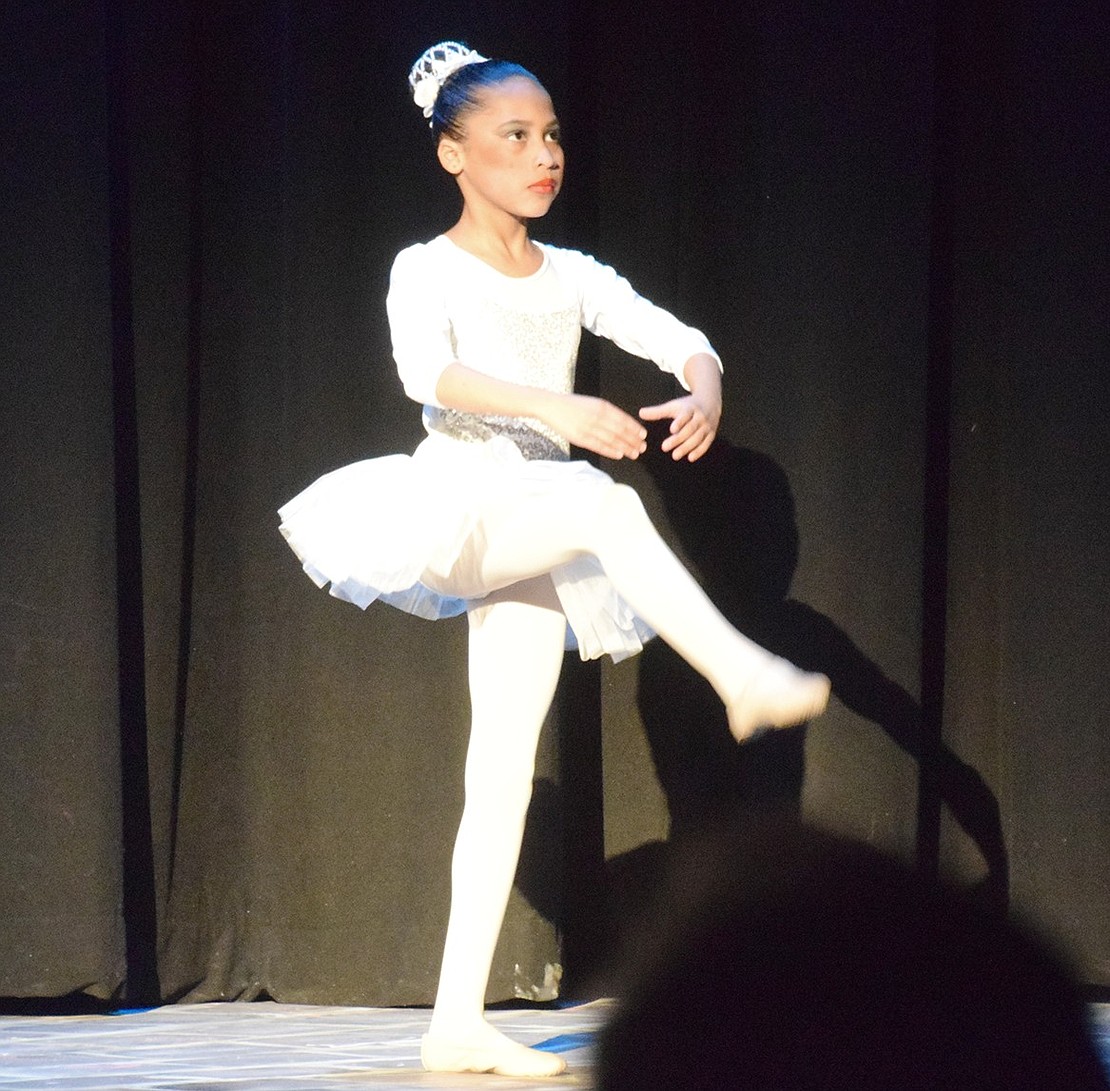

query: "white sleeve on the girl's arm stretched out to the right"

left=562, top=251, right=720, bottom=390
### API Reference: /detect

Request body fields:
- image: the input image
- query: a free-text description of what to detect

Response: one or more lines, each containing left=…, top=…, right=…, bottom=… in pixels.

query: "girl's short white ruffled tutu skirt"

left=279, top=433, right=653, bottom=661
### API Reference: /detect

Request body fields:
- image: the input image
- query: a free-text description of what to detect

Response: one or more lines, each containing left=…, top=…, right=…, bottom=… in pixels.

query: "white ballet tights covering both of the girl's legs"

left=428, top=479, right=823, bottom=1074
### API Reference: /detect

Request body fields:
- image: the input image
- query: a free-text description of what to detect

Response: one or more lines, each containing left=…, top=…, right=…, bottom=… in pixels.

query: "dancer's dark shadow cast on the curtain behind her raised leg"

left=608, top=437, right=1009, bottom=950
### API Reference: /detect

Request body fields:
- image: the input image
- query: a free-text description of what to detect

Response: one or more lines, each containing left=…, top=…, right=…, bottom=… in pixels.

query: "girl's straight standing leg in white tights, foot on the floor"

left=421, top=576, right=566, bottom=1077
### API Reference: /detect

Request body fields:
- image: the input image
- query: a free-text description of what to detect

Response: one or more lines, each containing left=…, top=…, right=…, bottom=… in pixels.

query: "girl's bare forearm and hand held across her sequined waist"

left=435, top=357, right=648, bottom=458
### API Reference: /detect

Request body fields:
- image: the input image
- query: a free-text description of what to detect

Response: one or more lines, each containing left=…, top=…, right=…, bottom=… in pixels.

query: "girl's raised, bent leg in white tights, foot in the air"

left=437, top=477, right=829, bottom=740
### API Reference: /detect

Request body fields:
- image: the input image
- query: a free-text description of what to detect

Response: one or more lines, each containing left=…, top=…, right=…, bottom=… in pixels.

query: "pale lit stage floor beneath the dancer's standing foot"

left=0, top=1001, right=1110, bottom=1091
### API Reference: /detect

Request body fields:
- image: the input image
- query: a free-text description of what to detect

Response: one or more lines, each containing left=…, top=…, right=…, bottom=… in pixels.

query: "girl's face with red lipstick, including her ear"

left=438, top=75, right=563, bottom=220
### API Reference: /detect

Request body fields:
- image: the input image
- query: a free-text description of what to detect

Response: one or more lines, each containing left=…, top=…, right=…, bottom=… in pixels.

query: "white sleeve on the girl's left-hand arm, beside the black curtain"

left=385, top=243, right=457, bottom=408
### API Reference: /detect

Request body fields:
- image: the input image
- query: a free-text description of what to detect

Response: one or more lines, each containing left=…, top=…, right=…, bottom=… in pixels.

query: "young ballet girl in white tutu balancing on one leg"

left=281, top=42, right=829, bottom=1077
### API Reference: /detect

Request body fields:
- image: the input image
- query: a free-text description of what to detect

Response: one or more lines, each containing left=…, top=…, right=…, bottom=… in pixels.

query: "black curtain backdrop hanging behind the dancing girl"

left=0, top=0, right=1110, bottom=1004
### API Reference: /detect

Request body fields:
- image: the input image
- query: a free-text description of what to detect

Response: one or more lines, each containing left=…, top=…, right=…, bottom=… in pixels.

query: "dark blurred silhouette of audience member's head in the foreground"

left=597, top=818, right=1110, bottom=1091
